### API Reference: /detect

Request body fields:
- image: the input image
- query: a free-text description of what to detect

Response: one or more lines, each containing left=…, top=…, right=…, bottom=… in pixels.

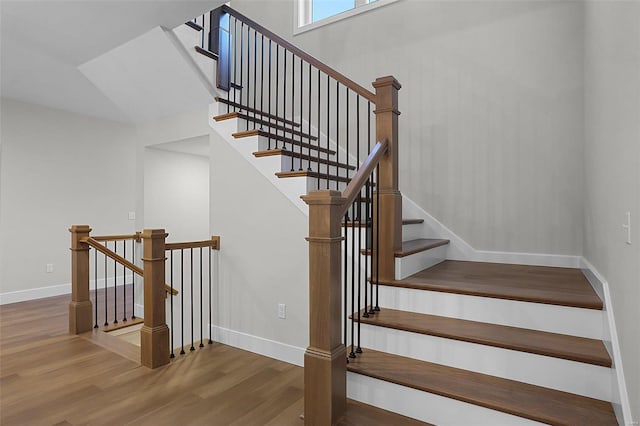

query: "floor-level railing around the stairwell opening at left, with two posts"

left=69, top=225, right=220, bottom=368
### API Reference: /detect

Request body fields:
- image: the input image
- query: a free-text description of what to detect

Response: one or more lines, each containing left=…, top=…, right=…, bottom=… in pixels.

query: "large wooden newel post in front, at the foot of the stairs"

left=302, top=190, right=347, bottom=426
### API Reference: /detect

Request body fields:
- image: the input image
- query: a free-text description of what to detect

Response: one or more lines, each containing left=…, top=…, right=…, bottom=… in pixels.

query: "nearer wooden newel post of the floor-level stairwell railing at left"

left=140, top=229, right=170, bottom=368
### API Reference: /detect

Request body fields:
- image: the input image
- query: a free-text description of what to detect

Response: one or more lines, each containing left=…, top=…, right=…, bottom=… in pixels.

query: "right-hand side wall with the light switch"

left=584, top=1, right=640, bottom=422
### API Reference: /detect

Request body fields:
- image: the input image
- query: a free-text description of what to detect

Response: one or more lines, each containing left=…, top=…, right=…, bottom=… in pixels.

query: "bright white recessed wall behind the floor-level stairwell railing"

left=144, top=146, right=211, bottom=242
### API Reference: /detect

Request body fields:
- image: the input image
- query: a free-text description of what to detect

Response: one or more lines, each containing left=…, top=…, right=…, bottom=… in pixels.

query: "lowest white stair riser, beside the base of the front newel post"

left=347, top=372, right=542, bottom=426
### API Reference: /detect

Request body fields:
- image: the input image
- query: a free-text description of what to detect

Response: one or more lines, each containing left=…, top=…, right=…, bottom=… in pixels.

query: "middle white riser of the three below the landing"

left=361, top=324, right=612, bottom=401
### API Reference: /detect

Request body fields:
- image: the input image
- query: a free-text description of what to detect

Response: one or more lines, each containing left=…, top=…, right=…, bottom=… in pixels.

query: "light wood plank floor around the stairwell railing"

left=0, top=296, right=430, bottom=426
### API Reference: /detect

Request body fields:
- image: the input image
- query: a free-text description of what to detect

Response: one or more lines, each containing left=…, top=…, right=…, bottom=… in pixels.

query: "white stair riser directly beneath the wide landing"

left=379, top=285, right=603, bottom=339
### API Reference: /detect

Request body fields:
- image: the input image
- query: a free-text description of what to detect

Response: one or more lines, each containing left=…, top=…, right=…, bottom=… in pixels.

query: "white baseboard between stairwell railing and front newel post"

left=211, top=325, right=305, bottom=367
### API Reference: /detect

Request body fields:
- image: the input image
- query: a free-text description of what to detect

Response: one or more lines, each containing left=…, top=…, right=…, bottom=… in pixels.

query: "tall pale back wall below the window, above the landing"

left=232, top=0, right=583, bottom=255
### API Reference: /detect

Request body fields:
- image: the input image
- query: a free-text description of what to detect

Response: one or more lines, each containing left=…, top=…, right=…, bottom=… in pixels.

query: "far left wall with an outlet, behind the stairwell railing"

left=0, top=98, right=136, bottom=302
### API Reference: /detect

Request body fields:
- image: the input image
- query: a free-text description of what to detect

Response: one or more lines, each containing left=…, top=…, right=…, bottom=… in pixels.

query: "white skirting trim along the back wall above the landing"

left=402, top=194, right=581, bottom=268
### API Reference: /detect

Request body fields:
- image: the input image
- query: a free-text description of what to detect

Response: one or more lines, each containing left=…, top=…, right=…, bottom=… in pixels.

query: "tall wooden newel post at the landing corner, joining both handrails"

left=373, top=76, right=402, bottom=280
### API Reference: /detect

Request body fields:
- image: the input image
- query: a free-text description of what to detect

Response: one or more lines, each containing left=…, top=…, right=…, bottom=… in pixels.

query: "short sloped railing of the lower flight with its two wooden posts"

left=303, top=77, right=402, bottom=425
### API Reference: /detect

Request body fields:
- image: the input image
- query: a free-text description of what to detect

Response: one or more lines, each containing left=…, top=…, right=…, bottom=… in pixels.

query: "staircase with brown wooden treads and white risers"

left=181, top=7, right=618, bottom=425
